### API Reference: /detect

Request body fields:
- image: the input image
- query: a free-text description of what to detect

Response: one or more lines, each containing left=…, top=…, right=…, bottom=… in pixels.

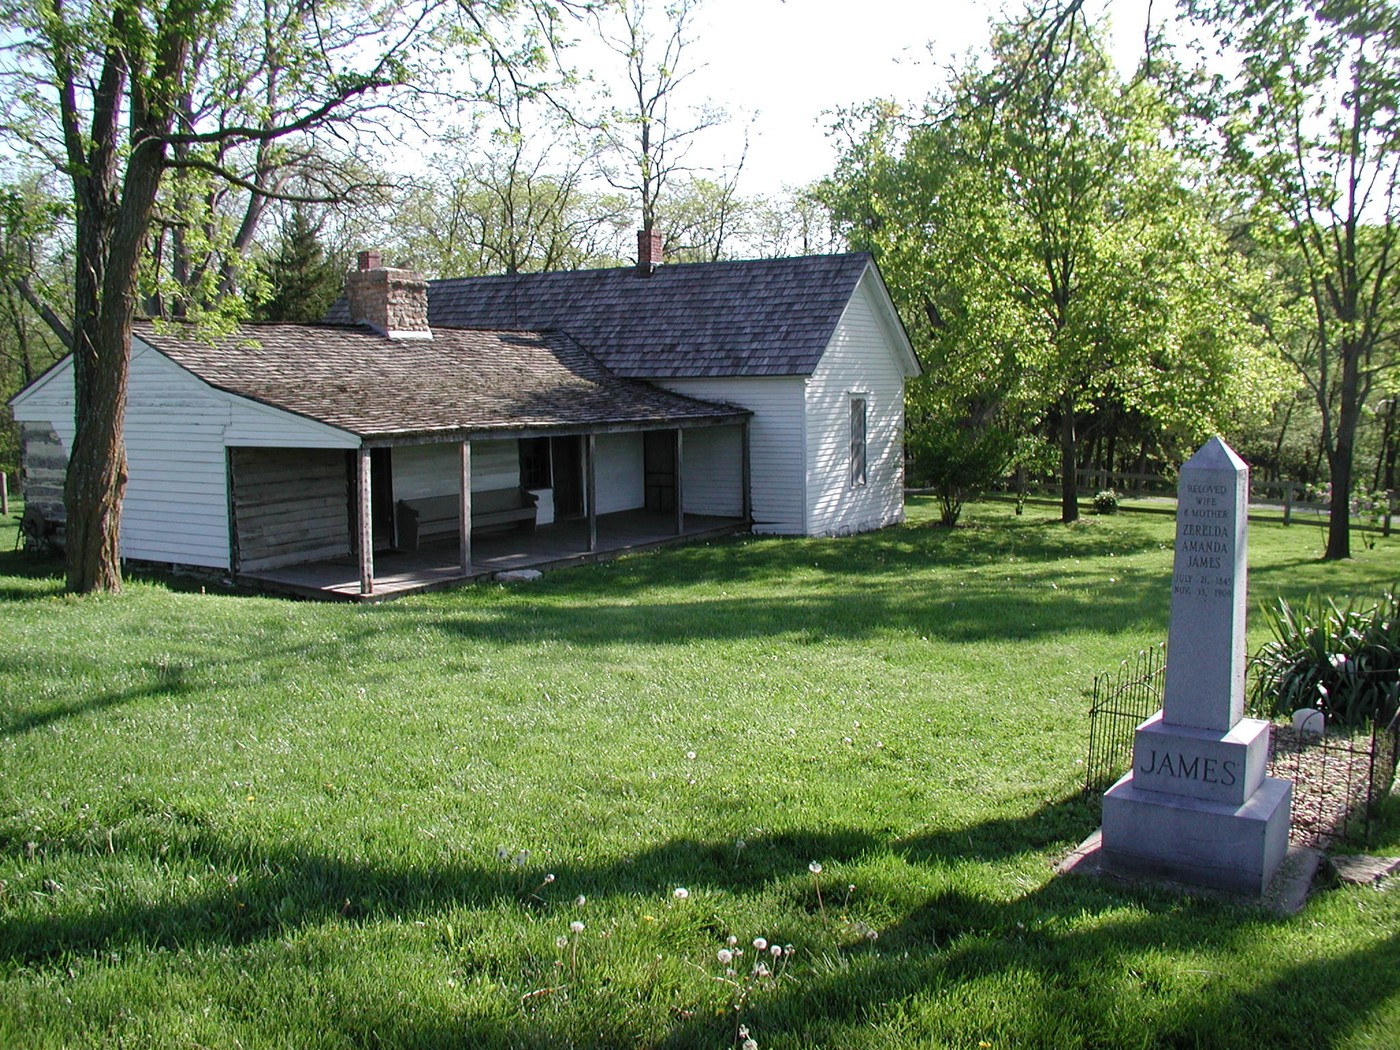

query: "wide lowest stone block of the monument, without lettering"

left=1102, top=773, right=1294, bottom=896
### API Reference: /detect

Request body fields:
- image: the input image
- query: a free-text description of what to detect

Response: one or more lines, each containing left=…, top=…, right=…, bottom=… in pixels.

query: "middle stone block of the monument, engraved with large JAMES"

left=1133, top=711, right=1268, bottom=806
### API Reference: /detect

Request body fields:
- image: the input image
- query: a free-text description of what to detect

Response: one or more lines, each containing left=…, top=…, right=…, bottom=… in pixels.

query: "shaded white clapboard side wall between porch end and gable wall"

left=658, top=377, right=806, bottom=536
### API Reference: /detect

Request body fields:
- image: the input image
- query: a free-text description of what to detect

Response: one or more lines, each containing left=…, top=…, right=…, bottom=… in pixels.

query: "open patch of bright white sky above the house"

left=618, top=0, right=1153, bottom=196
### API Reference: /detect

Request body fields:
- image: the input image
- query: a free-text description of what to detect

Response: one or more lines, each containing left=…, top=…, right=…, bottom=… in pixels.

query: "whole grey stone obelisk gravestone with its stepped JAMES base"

left=1100, top=437, right=1292, bottom=895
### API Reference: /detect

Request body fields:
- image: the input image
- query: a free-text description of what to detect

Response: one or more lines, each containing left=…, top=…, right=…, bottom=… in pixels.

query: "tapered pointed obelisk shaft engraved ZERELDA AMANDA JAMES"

left=1162, top=437, right=1249, bottom=732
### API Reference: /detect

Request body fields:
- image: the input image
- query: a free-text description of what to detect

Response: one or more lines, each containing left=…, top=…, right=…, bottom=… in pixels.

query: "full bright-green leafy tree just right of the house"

left=829, top=17, right=1271, bottom=522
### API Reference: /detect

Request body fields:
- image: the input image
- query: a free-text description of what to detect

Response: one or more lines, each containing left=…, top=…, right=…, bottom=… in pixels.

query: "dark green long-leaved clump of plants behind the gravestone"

left=1252, top=588, right=1400, bottom=725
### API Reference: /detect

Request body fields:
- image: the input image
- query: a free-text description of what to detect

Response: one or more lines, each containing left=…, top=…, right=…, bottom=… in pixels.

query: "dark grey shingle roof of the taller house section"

left=329, top=253, right=871, bottom=379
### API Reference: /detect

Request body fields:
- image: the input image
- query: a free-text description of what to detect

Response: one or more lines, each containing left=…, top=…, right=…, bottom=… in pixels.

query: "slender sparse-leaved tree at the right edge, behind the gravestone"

left=1184, top=0, right=1400, bottom=559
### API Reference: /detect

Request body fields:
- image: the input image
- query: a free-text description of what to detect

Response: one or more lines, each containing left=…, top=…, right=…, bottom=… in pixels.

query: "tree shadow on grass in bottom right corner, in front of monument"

left=664, top=879, right=1400, bottom=1050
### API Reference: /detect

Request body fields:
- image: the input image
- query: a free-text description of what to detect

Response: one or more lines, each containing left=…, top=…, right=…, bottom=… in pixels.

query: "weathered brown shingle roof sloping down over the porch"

left=134, top=322, right=749, bottom=438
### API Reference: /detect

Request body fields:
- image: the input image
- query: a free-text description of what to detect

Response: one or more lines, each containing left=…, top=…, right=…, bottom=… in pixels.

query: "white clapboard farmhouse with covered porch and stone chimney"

left=11, top=240, right=918, bottom=599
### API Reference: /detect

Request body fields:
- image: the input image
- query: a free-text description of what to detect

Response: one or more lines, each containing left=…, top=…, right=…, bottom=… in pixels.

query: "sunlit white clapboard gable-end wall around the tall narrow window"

left=806, top=274, right=904, bottom=535
